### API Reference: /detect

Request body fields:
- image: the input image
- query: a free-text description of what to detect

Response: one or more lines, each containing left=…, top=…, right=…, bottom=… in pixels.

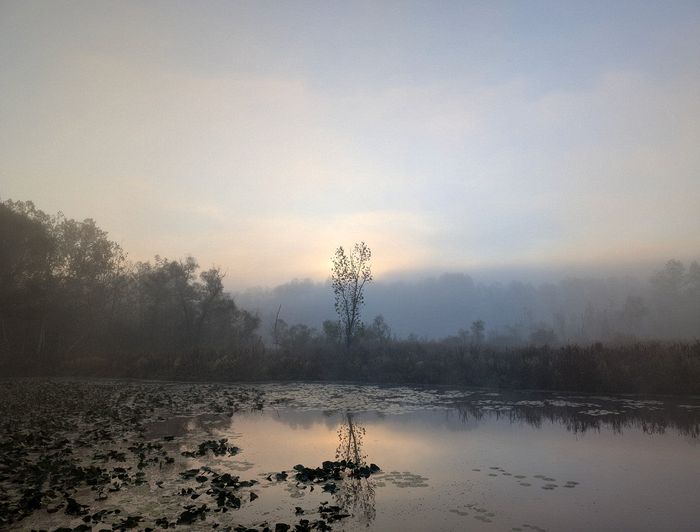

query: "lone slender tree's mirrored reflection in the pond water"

left=335, top=412, right=377, bottom=524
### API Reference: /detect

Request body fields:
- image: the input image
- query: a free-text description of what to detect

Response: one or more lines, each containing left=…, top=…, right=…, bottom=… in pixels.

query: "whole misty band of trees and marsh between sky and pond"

left=0, top=200, right=700, bottom=393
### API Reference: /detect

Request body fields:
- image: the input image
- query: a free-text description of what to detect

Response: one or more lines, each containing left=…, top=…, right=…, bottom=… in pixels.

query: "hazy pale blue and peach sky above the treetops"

left=0, top=0, right=700, bottom=286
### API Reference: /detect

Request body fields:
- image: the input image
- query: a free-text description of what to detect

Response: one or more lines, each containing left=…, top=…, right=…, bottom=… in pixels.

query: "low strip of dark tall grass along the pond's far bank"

left=5, top=340, right=700, bottom=395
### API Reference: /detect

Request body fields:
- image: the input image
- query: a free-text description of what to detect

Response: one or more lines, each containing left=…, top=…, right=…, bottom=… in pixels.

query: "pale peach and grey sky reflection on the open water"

left=226, top=410, right=700, bottom=530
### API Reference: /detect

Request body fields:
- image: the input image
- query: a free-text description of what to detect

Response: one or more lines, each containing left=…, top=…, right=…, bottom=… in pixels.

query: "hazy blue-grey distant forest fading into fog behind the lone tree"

left=241, top=260, right=700, bottom=347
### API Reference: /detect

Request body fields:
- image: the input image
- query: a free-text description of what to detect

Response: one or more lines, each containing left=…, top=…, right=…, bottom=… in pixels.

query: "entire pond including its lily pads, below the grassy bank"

left=0, top=381, right=700, bottom=531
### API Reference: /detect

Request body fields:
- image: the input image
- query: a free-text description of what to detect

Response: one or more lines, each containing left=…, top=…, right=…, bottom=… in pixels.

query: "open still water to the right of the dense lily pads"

left=150, top=385, right=700, bottom=531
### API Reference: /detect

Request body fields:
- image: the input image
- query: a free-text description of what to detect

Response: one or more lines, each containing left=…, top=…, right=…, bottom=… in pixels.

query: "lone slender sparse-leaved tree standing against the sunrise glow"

left=331, top=242, right=372, bottom=347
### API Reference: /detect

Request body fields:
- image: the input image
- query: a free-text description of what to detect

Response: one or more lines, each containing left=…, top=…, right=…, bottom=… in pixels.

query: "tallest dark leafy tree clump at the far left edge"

left=0, top=201, right=125, bottom=362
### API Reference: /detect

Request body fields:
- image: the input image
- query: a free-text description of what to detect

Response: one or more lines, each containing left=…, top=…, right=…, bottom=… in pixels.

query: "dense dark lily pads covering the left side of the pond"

left=0, top=380, right=380, bottom=532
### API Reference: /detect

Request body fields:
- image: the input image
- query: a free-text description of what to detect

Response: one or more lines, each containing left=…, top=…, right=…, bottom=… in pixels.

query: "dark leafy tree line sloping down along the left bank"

left=0, top=200, right=261, bottom=371
